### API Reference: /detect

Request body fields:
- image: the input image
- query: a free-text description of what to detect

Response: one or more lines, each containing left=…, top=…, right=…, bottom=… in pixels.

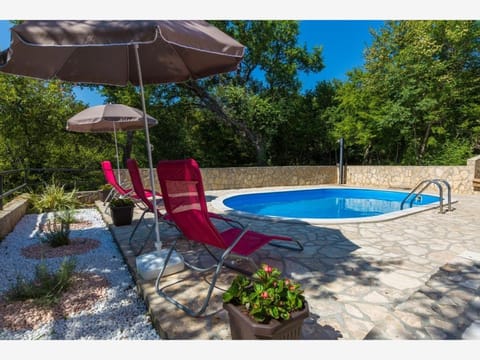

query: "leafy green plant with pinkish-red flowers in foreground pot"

left=222, top=264, right=305, bottom=323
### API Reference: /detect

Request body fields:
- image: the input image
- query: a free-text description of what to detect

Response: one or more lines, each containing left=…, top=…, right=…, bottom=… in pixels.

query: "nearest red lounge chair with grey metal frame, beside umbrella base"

left=155, top=159, right=303, bottom=316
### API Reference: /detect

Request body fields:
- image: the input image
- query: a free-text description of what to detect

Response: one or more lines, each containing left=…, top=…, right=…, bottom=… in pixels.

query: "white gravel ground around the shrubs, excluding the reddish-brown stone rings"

left=0, top=208, right=160, bottom=340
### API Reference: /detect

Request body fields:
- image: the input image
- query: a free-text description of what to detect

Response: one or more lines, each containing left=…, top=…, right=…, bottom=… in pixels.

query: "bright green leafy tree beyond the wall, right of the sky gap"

left=336, top=20, right=480, bottom=164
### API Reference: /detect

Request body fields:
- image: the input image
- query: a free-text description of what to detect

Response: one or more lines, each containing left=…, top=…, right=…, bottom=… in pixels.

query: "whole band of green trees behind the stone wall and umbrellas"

left=0, top=20, right=480, bottom=169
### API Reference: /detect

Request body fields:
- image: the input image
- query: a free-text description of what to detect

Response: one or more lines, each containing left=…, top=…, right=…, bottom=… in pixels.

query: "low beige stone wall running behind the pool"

left=117, top=156, right=480, bottom=194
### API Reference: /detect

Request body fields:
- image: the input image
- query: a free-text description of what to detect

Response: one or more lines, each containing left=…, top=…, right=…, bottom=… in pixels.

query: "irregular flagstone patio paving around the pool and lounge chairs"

left=96, top=190, right=480, bottom=340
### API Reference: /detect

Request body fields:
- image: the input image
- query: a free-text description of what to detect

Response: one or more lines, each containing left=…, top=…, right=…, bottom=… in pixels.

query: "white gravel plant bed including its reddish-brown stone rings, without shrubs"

left=0, top=208, right=159, bottom=341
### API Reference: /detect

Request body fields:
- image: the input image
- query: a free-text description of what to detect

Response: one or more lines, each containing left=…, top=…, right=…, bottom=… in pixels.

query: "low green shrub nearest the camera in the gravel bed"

left=4, top=259, right=76, bottom=306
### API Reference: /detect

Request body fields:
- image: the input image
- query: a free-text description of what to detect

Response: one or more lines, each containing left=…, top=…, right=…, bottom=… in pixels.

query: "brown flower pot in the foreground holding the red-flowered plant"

left=223, top=302, right=310, bottom=340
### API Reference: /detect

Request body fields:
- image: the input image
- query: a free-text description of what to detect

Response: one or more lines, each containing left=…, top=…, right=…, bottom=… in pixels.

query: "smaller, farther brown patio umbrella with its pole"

left=67, top=104, right=158, bottom=182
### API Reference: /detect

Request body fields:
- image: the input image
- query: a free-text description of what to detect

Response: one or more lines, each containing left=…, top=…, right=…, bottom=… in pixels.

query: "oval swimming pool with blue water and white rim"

left=212, top=187, right=440, bottom=223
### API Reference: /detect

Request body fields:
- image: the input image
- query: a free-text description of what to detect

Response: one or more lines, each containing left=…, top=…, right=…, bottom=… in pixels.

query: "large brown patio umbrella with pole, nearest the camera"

left=0, top=20, right=245, bottom=256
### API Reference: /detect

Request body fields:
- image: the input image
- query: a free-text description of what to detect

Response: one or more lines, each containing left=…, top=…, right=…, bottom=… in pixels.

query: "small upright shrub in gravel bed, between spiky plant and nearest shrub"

left=40, top=210, right=75, bottom=247
